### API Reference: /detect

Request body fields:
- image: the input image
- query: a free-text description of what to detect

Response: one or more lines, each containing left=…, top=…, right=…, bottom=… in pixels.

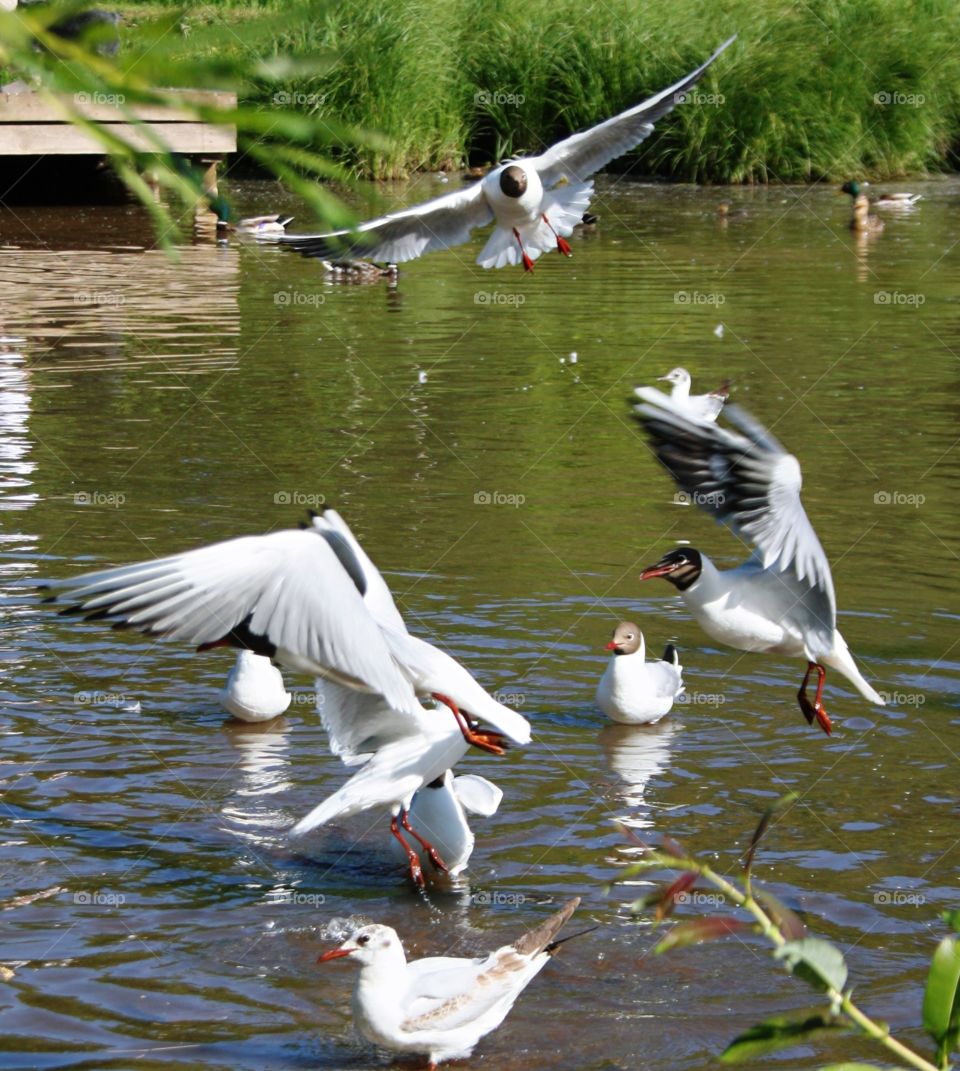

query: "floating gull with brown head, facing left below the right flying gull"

left=597, top=621, right=684, bottom=725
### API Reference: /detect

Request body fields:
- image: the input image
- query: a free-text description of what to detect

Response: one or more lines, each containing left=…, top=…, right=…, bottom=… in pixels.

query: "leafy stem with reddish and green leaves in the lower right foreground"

left=618, top=794, right=960, bottom=1071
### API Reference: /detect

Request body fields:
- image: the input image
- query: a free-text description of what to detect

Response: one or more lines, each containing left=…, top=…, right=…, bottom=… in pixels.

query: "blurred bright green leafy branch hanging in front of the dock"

left=0, top=0, right=386, bottom=245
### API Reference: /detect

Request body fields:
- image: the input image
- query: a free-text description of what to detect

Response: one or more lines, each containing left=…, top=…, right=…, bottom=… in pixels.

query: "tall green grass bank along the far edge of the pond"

left=121, top=0, right=960, bottom=182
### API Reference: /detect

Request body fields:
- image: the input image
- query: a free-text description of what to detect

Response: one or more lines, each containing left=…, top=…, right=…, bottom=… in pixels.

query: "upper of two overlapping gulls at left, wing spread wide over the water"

left=46, top=511, right=530, bottom=754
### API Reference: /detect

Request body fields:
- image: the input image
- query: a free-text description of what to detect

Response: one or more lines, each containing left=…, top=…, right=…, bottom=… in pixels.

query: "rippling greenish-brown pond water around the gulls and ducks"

left=0, top=176, right=960, bottom=1071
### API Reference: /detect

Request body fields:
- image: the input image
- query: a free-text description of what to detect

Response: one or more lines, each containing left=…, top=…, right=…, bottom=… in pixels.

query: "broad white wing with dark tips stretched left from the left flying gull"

left=48, top=528, right=420, bottom=714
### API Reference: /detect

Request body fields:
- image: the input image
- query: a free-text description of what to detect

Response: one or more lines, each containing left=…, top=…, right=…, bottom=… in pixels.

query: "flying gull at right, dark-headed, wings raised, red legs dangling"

left=636, top=388, right=884, bottom=735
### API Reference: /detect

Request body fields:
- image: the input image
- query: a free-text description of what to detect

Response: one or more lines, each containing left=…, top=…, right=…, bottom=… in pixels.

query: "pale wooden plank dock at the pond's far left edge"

left=0, top=90, right=237, bottom=192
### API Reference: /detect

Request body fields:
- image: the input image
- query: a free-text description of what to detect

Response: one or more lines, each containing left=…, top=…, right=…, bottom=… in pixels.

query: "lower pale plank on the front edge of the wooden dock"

left=0, top=123, right=237, bottom=156
